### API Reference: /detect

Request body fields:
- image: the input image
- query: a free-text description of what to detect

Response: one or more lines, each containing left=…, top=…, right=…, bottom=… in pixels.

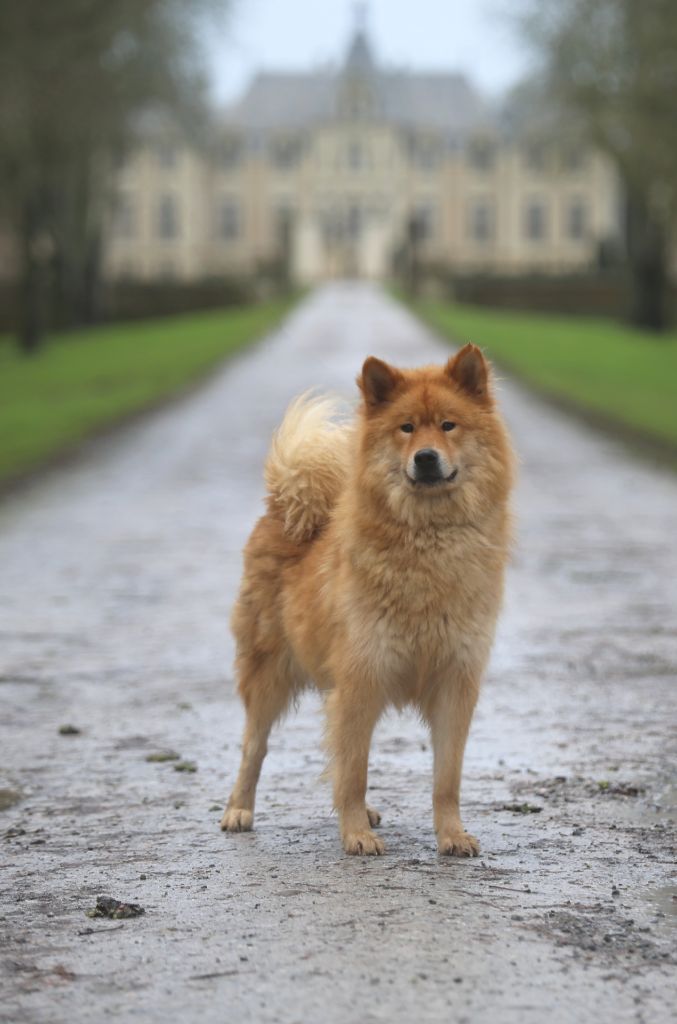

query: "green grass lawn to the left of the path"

left=0, top=300, right=290, bottom=483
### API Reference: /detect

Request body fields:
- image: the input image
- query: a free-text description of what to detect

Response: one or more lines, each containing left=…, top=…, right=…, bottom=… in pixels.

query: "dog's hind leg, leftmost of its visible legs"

left=221, top=659, right=297, bottom=831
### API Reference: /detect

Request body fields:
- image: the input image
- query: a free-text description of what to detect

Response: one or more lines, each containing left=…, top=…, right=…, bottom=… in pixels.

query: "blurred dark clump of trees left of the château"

left=0, top=0, right=229, bottom=352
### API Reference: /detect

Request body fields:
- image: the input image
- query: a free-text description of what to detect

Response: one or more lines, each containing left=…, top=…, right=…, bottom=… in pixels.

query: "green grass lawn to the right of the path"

left=414, top=300, right=677, bottom=450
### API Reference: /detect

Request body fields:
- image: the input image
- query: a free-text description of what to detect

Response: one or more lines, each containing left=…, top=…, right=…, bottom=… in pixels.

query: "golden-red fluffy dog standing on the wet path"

left=221, top=345, right=513, bottom=856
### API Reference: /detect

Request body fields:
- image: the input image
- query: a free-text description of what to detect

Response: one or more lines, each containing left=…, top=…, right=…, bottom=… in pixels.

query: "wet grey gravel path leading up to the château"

left=0, top=285, right=677, bottom=1024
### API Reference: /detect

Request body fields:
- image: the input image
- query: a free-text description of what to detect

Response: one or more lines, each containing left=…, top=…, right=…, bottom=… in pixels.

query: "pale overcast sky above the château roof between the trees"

left=209, top=0, right=528, bottom=101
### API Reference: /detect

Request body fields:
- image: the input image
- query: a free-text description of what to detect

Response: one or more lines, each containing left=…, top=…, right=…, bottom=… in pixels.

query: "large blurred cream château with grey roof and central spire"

left=104, top=25, right=619, bottom=284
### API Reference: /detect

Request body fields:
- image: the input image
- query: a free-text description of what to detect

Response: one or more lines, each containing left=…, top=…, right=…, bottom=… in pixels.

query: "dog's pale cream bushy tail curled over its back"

left=265, top=393, right=351, bottom=544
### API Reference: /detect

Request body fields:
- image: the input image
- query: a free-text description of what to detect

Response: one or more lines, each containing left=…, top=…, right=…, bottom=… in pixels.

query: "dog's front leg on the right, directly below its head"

left=427, top=677, right=479, bottom=857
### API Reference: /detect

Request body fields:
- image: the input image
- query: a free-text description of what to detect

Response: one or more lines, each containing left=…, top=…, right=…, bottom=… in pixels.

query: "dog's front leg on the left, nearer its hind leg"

left=327, top=683, right=384, bottom=856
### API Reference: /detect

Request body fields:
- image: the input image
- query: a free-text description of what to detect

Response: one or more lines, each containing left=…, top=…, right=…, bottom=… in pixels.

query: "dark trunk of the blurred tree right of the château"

left=628, top=193, right=670, bottom=332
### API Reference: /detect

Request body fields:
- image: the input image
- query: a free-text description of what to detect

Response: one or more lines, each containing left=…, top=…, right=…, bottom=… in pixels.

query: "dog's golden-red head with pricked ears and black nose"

left=357, top=345, right=512, bottom=522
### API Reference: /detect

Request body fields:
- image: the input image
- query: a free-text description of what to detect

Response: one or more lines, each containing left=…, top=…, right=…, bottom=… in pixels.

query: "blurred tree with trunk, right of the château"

left=525, top=0, right=677, bottom=331
